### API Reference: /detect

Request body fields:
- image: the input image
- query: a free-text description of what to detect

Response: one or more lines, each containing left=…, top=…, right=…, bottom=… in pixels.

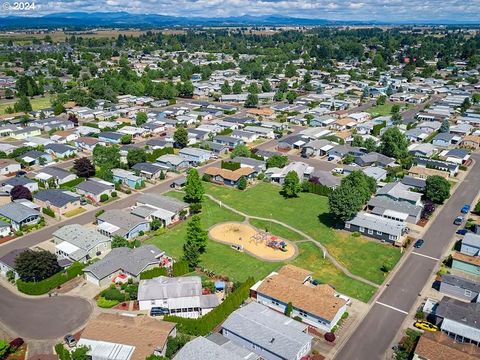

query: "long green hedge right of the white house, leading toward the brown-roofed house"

left=164, top=277, right=255, bottom=336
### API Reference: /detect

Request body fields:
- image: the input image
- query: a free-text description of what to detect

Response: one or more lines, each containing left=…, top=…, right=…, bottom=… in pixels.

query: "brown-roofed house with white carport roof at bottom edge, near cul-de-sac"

left=78, top=313, right=176, bottom=360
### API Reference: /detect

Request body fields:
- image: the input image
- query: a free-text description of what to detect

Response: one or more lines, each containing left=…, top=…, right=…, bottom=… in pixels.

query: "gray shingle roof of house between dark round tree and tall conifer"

left=84, top=245, right=163, bottom=280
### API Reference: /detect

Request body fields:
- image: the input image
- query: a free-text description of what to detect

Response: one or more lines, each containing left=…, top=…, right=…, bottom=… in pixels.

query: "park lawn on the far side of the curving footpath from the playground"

left=205, top=183, right=401, bottom=284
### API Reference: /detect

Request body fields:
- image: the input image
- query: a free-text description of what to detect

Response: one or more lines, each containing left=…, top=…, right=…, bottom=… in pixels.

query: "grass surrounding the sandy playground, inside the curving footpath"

left=147, top=188, right=376, bottom=302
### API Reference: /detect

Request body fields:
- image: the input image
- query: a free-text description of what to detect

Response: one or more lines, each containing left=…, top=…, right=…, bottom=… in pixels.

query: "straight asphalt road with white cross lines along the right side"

left=335, top=154, right=480, bottom=360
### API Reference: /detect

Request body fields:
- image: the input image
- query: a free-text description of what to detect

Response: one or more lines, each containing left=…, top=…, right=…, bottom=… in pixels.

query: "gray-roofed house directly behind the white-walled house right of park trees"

left=367, top=196, right=423, bottom=224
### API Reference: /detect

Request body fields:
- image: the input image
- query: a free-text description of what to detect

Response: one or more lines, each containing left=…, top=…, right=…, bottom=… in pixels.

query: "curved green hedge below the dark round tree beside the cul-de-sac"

left=17, top=262, right=85, bottom=295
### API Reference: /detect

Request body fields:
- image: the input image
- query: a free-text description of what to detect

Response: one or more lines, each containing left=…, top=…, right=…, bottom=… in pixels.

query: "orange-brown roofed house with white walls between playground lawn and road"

left=250, top=265, right=350, bottom=331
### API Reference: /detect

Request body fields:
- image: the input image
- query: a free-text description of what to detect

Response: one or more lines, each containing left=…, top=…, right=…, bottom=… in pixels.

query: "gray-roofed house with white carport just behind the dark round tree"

left=52, top=224, right=112, bottom=262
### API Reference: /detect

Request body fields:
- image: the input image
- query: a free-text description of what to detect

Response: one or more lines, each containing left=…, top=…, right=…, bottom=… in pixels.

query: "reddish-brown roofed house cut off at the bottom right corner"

left=413, top=331, right=480, bottom=360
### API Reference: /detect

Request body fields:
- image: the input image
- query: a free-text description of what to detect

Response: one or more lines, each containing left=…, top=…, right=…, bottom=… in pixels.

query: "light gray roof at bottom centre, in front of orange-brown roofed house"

left=222, top=302, right=312, bottom=359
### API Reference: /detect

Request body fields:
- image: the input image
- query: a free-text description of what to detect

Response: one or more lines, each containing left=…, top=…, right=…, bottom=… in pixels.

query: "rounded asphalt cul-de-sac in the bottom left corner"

left=0, top=286, right=93, bottom=340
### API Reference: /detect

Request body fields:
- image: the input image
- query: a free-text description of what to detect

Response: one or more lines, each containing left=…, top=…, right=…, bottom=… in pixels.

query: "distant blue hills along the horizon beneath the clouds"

left=0, top=12, right=478, bottom=29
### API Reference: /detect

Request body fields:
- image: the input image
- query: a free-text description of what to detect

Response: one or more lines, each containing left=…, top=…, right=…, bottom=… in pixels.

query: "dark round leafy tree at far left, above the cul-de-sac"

left=15, top=250, right=61, bottom=282
